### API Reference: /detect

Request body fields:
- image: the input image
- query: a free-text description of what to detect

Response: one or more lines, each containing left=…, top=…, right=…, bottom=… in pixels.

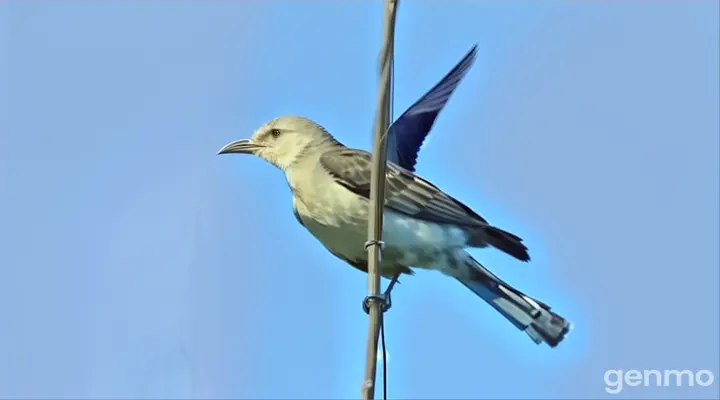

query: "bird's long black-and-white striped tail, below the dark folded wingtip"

left=458, top=254, right=571, bottom=347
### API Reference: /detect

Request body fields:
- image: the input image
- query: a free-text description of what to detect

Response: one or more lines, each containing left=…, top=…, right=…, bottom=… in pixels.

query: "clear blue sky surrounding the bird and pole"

left=0, top=1, right=720, bottom=399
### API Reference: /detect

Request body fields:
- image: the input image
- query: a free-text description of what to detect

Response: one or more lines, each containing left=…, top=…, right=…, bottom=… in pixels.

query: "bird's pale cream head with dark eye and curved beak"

left=218, top=115, right=338, bottom=170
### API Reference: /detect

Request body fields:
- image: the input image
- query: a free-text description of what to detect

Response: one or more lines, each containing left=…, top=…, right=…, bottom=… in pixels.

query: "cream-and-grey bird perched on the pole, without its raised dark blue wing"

left=218, top=115, right=571, bottom=347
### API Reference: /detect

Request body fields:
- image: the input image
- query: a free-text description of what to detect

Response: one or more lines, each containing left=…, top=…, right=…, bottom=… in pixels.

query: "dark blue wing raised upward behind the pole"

left=387, top=45, right=477, bottom=171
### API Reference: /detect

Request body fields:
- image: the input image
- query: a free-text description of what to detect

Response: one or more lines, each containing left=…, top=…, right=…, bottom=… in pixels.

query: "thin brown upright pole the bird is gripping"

left=362, top=0, right=398, bottom=400
